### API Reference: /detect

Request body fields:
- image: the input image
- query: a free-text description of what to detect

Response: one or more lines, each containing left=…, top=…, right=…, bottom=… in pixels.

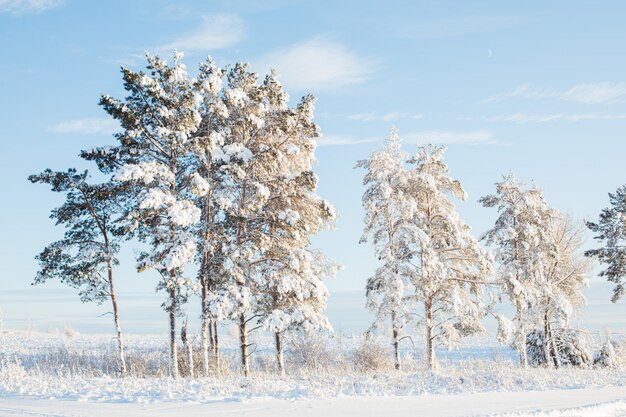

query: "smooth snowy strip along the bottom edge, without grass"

left=0, top=387, right=626, bottom=417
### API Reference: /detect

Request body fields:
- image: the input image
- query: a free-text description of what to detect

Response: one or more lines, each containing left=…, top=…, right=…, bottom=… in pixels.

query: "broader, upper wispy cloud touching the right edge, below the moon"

left=482, top=82, right=626, bottom=104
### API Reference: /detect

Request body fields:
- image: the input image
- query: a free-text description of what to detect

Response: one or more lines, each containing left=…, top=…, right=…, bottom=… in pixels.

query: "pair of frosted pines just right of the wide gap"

left=357, top=131, right=492, bottom=369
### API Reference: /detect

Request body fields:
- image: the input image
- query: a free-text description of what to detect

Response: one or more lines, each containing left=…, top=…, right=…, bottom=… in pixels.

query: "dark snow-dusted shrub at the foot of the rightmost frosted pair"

left=526, top=329, right=592, bottom=368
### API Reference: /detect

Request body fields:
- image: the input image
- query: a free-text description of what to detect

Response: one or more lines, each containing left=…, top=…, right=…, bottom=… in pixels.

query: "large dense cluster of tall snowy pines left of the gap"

left=29, top=52, right=337, bottom=376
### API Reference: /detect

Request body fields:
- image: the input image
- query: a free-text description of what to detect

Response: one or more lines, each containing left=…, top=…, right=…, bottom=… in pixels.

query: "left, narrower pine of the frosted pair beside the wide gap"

left=356, top=129, right=418, bottom=369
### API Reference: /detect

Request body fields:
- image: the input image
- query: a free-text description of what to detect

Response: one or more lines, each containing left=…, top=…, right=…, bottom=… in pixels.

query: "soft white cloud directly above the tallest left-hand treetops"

left=154, top=14, right=244, bottom=53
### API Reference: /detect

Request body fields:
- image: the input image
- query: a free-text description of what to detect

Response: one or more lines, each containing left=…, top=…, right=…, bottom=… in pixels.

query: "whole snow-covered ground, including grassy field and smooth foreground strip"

left=0, top=331, right=626, bottom=417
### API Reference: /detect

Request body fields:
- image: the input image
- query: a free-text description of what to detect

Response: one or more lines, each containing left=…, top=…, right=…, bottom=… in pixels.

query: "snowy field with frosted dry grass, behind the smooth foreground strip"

left=0, top=333, right=626, bottom=404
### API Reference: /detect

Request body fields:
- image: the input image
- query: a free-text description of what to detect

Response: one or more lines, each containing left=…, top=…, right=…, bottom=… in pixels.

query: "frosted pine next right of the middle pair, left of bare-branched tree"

left=479, top=174, right=558, bottom=367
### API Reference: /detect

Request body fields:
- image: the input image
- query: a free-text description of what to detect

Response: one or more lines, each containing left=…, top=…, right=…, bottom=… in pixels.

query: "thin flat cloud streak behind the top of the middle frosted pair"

left=317, top=130, right=507, bottom=146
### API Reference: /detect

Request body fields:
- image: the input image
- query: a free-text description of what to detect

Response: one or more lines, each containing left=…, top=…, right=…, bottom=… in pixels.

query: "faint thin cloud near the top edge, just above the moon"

left=390, top=16, right=538, bottom=39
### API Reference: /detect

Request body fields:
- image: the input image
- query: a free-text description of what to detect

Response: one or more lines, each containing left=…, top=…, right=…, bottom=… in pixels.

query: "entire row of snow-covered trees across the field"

left=29, top=52, right=626, bottom=376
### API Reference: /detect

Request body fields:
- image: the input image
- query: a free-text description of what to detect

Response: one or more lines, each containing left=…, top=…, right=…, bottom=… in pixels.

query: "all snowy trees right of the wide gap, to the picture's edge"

left=357, top=130, right=626, bottom=369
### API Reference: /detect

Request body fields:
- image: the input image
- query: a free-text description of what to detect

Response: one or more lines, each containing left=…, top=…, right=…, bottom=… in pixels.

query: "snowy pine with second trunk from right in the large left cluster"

left=195, top=64, right=288, bottom=375
